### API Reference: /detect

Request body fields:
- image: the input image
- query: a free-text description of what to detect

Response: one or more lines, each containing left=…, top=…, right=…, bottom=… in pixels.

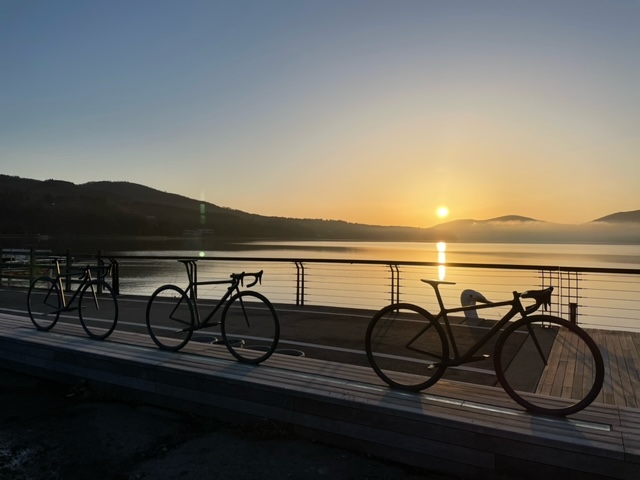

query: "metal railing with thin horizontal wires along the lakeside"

left=0, top=251, right=640, bottom=331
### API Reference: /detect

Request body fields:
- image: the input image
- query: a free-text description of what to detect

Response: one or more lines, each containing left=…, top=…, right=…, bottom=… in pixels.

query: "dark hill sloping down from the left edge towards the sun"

left=0, top=175, right=442, bottom=241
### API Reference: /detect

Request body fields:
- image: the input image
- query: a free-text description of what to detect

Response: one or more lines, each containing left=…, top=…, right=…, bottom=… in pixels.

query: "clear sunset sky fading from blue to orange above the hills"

left=0, top=0, right=640, bottom=227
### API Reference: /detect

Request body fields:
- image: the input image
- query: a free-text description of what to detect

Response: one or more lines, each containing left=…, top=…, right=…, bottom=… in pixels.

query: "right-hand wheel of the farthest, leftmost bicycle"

left=78, top=280, right=118, bottom=340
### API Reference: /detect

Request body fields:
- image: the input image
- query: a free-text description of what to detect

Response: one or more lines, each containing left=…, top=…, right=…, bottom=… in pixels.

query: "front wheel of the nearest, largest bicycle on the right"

left=494, top=315, right=604, bottom=416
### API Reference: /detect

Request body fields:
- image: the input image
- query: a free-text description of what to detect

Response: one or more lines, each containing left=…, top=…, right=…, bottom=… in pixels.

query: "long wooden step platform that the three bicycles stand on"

left=0, top=313, right=640, bottom=480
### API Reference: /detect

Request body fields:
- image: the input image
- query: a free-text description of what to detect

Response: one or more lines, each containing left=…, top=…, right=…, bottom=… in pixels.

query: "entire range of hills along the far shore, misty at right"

left=0, top=175, right=640, bottom=243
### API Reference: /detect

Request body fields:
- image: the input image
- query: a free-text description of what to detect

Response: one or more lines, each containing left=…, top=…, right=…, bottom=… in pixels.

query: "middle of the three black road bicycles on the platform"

left=146, top=260, right=280, bottom=364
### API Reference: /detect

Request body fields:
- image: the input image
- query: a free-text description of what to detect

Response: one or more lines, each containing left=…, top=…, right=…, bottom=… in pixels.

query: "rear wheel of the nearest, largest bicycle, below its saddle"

left=365, top=303, right=449, bottom=391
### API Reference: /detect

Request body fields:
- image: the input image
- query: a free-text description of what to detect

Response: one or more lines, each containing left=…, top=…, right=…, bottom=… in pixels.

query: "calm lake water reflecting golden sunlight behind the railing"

left=105, top=239, right=640, bottom=329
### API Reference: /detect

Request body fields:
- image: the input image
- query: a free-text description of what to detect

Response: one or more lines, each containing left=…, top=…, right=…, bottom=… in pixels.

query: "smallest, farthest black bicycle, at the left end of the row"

left=27, top=259, right=118, bottom=340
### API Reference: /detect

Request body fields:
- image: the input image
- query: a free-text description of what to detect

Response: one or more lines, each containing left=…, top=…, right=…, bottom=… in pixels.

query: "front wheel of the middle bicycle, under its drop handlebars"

left=220, top=290, right=280, bottom=363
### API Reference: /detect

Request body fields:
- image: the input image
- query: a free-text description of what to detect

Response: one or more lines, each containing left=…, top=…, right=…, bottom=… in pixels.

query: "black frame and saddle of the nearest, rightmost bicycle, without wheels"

left=416, top=280, right=540, bottom=367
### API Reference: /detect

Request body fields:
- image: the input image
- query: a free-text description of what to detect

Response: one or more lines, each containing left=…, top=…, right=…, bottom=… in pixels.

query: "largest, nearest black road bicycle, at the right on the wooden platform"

left=365, top=280, right=604, bottom=416
